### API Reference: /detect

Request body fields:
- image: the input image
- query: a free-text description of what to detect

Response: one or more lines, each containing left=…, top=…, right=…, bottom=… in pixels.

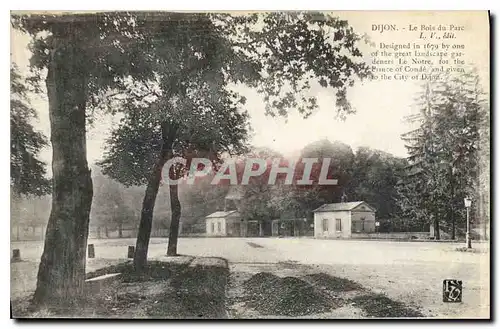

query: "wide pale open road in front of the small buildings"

left=12, top=238, right=489, bottom=317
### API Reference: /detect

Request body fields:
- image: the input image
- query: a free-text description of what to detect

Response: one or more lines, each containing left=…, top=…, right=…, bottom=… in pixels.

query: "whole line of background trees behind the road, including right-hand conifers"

left=12, top=67, right=486, bottom=242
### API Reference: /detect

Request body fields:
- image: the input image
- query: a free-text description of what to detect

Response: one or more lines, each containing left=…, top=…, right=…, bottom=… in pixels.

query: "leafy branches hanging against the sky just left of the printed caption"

left=215, top=12, right=370, bottom=117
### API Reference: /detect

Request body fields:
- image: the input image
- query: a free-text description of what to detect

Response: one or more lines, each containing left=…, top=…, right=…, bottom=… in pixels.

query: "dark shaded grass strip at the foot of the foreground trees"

left=12, top=261, right=229, bottom=319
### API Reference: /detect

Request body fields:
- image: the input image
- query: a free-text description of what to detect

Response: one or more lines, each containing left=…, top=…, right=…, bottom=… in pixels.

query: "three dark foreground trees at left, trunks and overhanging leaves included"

left=13, top=12, right=369, bottom=305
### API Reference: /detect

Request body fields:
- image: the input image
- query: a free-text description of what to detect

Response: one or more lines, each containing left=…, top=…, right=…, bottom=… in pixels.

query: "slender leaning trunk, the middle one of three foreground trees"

left=134, top=122, right=177, bottom=271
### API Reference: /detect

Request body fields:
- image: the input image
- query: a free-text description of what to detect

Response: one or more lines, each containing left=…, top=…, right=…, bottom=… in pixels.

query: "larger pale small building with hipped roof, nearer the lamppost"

left=313, top=201, right=375, bottom=238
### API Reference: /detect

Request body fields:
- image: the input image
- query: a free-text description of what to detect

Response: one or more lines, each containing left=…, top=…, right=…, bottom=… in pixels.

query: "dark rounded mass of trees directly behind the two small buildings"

left=221, top=139, right=407, bottom=226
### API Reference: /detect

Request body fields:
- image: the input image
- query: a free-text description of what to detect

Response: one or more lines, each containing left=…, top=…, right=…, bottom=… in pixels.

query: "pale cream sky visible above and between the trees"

left=11, top=11, right=489, bottom=169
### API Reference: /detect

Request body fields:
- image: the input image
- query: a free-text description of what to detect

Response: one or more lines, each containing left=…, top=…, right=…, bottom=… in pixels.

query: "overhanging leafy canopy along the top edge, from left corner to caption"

left=13, top=12, right=370, bottom=116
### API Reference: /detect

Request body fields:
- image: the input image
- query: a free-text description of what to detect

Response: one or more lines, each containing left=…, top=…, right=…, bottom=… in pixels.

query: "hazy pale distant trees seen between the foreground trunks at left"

left=10, top=166, right=227, bottom=240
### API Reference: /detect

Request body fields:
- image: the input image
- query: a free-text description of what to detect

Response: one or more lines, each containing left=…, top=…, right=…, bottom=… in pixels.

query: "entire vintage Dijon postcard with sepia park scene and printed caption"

left=10, top=11, right=491, bottom=319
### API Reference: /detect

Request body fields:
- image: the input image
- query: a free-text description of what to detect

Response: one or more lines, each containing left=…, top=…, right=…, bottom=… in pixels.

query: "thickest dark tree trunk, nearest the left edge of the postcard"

left=33, top=42, right=92, bottom=305
